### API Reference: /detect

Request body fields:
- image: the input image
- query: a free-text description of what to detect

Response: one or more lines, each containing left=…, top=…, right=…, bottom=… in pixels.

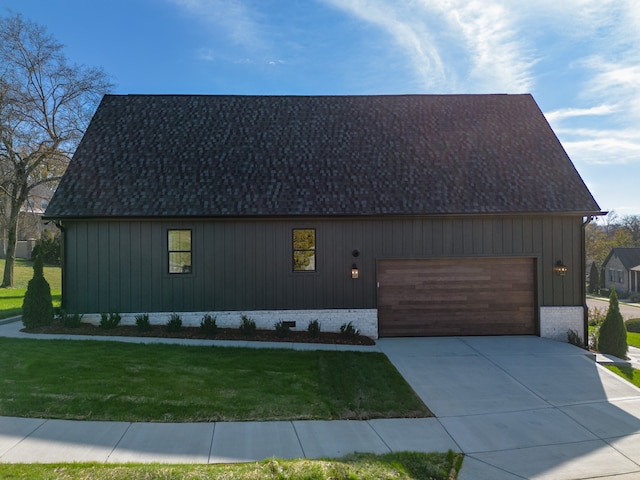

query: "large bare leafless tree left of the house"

left=0, top=15, right=111, bottom=287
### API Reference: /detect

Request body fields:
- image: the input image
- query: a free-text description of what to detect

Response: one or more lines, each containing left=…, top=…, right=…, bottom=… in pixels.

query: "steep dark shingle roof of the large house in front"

left=46, top=95, right=600, bottom=218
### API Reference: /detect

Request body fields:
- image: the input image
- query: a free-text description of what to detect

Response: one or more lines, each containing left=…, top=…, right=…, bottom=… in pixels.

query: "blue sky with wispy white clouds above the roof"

left=0, top=0, right=640, bottom=215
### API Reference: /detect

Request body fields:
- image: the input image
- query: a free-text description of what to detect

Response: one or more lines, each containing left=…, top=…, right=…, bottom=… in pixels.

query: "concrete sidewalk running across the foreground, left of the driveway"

left=0, top=417, right=457, bottom=463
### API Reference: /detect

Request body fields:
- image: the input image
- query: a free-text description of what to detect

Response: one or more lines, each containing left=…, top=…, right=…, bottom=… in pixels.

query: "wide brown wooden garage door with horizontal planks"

left=378, top=258, right=536, bottom=337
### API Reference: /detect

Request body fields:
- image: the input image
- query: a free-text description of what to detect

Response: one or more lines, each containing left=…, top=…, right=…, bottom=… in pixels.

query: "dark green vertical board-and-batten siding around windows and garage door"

left=62, top=215, right=584, bottom=313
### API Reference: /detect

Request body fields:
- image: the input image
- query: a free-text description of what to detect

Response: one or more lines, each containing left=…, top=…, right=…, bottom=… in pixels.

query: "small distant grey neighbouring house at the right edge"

left=602, top=247, right=640, bottom=298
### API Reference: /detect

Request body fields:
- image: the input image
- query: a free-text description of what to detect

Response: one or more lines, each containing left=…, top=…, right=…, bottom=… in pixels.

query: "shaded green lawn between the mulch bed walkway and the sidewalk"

left=0, top=338, right=431, bottom=422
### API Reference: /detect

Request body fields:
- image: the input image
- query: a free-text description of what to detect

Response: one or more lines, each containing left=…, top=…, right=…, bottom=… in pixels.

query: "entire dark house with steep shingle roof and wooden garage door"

left=46, top=95, right=600, bottom=341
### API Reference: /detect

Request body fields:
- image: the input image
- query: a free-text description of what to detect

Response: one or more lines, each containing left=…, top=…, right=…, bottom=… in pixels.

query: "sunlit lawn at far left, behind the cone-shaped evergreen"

left=0, top=258, right=62, bottom=319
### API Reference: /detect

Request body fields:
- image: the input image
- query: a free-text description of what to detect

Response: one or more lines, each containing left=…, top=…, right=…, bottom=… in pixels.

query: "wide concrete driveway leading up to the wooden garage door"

left=379, top=336, right=640, bottom=480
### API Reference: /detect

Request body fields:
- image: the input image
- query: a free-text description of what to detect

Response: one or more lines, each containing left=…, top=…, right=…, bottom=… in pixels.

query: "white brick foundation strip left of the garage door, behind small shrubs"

left=82, top=309, right=378, bottom=339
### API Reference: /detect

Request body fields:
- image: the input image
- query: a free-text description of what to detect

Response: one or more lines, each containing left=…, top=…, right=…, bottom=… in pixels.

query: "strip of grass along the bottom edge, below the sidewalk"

left=0, top=452, right=462, bottom=480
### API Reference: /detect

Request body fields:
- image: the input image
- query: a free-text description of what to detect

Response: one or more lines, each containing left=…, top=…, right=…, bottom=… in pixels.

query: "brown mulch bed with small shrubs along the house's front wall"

left=21, top=322, right=376, bottom=345
